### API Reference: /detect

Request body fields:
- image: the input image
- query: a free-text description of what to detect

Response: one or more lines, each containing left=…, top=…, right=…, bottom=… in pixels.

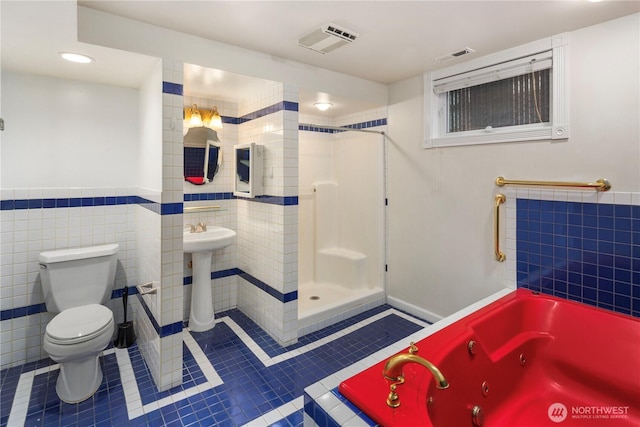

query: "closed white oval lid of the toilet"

left=46, top=304, right=113, bottom=344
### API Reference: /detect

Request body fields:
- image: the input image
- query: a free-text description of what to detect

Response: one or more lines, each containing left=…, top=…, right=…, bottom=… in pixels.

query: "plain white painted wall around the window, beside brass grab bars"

left=387, top=14, right=640, bottom=318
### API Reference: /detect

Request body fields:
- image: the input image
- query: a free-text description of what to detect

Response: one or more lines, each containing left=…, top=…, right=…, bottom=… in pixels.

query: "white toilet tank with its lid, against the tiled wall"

left=39, top=244, right=119, bottom=313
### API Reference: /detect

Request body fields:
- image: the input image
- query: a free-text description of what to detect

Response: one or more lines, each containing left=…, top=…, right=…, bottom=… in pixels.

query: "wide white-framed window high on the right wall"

left=425, top=34, right=569, bottom=148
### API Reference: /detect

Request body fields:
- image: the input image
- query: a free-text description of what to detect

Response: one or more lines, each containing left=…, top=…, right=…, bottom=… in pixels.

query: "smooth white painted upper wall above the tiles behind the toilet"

left=1, top=71, right=139, bottom=188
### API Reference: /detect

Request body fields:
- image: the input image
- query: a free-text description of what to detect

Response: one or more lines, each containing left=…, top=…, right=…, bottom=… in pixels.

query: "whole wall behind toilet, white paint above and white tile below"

left=0, top=71, right=138, bottom=369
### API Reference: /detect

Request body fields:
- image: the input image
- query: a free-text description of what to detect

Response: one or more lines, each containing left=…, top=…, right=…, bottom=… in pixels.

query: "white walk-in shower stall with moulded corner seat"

left=298, top=125, right=385, bottom=336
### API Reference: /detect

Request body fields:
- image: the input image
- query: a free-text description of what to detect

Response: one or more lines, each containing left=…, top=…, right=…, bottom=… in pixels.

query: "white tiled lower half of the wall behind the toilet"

left=0, top=188, right=136, bottom=369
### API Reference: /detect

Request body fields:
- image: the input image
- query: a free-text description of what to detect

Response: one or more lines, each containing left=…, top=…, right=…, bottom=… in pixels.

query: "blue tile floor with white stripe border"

left=0, top=305, right=424, bottom=427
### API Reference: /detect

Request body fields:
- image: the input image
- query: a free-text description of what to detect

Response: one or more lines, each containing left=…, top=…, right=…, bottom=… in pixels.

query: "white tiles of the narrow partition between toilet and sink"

left=131, top=59, right=184, bottom=390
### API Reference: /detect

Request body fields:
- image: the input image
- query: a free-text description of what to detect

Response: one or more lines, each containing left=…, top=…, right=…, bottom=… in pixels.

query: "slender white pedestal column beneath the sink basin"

left=189, top=251, right=215, bottom=332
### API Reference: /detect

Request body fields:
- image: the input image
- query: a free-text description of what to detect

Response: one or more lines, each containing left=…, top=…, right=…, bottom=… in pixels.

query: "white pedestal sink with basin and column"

left=183, top=226, right=236, bottom=332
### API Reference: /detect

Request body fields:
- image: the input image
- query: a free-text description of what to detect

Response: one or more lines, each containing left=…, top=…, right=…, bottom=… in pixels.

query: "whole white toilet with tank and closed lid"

left=39, top=244, right=119, bottom=403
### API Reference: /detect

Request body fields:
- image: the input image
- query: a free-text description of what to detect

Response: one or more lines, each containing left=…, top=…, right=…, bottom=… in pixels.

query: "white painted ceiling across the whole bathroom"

left=0, top=0, right=640, bottom=112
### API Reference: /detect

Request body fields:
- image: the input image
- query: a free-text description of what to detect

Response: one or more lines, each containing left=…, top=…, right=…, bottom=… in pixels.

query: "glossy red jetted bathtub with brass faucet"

left=339, top=289, right=640, bottom=427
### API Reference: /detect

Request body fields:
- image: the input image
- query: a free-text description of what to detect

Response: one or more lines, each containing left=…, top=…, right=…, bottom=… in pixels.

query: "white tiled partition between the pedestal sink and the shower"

left=231, top=78, right=298, bottom=344
